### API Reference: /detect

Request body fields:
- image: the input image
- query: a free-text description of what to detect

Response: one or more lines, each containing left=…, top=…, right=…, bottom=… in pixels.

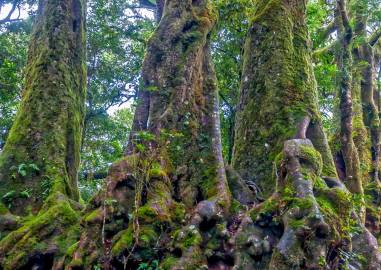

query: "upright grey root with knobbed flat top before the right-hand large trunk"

left=270, top=139, right=330, bottom=269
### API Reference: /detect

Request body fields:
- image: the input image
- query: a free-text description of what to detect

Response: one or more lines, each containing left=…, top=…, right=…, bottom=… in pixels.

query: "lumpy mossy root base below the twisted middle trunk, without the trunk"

left=68, top=147, right=233, bottom=269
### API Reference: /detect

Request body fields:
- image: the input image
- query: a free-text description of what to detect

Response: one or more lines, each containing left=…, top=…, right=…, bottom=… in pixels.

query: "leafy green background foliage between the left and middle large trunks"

left=80, top=1, right=154, bottom=186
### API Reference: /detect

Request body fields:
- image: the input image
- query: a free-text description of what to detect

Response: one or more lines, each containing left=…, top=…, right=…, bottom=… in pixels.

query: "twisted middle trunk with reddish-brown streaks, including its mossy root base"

left=69, top=0, right=230, bottom=269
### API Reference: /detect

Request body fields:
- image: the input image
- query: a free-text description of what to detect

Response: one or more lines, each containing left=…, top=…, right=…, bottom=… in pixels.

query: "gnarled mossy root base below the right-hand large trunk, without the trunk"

left=235, top=139, right=381, bottom=269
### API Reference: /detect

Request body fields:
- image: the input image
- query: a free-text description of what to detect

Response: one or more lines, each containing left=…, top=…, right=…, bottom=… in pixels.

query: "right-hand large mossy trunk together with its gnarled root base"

left=233, top=0, right=380, bottom=269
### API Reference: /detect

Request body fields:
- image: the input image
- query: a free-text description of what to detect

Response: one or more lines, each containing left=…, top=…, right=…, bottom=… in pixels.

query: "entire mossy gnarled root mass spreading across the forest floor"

left=0, top=139, right=381, bottom=269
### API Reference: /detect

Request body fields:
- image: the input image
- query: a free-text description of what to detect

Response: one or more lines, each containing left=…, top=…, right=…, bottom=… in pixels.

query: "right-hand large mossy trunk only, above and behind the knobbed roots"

left=232, top=0, right=336, bottom=196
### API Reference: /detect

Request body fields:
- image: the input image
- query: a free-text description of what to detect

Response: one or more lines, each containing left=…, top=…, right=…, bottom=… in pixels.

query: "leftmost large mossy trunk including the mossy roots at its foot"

left=0, top=0, right=86, bottom=269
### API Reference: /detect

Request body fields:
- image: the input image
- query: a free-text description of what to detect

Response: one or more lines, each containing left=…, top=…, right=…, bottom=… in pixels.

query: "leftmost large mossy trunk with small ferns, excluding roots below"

left=0, top=0, right=86, bottom=214
